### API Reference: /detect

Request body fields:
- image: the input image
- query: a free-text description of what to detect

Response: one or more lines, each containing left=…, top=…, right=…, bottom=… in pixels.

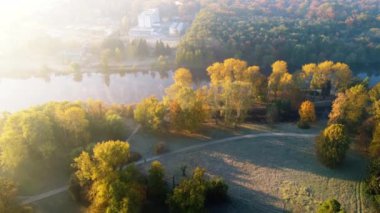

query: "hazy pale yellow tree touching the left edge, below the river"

left=0, top=110, right=57, bottom=170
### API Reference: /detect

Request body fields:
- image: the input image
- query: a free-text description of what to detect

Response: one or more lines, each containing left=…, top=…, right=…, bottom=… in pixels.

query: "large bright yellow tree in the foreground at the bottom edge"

left=72, top=141, right=145, bottom=212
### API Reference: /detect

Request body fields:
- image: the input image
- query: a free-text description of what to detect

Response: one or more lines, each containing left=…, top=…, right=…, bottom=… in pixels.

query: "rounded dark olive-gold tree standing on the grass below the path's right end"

left=316, top=124, right=350, bottom=168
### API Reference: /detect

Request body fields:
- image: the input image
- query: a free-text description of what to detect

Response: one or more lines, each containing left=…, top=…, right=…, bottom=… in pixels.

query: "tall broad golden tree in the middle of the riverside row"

left=207, top=58, right=265, bottom=125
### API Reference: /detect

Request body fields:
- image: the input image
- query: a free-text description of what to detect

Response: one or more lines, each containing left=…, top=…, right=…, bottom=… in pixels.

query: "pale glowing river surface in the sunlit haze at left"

left=0, top=72, right=173, bottom=112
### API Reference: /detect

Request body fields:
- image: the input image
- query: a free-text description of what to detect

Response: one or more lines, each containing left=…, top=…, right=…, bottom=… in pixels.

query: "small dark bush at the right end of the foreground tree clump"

left=206, top=178, right=228, bottom=204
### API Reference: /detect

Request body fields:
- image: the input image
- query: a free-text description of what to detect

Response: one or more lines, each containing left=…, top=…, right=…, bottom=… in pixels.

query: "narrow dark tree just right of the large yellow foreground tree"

left=148, top=161, right=168, bottom=202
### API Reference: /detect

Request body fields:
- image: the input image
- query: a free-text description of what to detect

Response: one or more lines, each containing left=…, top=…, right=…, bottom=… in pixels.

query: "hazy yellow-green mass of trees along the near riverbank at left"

left=0, top=101, right=133, bottom=176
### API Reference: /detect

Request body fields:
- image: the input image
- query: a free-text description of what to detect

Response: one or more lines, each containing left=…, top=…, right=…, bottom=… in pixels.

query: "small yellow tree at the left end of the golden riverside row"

left=134, top=96, right=165, bottom=131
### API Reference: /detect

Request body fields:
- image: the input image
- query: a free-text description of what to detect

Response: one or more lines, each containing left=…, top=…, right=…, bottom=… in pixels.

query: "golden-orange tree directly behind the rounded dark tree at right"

left=329, top=85, right=369, bottom=131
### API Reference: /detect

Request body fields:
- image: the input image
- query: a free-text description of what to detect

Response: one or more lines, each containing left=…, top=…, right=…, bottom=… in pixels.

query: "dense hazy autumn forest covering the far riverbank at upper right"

left=177, top=0, right=380, bottom=75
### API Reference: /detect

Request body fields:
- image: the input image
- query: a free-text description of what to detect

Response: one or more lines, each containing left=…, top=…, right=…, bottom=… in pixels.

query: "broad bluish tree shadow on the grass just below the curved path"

left=190, top=137, right=367, bottom=181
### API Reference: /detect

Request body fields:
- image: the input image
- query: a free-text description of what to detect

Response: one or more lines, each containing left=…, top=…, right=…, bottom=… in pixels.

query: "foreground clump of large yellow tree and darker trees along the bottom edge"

left=70, top=141, right=228, bottom=213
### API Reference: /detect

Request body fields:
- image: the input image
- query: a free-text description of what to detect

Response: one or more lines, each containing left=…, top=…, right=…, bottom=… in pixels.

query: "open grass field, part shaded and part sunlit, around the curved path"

left=31, top=123, right=374, bottom=212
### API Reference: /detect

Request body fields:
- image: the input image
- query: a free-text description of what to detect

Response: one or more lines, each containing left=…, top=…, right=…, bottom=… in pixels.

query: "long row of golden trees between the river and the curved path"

left=134, top=58, right=353, bottom=131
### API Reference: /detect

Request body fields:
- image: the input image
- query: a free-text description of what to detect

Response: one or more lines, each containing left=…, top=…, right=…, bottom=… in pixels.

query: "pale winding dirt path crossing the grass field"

left=22, top=132, right=316, bottom=204
